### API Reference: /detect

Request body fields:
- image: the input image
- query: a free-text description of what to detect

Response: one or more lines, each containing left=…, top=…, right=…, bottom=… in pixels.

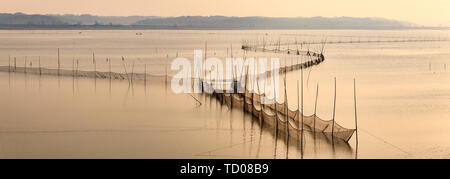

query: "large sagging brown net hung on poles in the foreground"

left=208, top=85, right=355, bottom=142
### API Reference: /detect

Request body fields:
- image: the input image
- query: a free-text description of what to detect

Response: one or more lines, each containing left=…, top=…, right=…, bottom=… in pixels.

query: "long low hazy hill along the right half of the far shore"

left=136, top=16, right=413, bottom=29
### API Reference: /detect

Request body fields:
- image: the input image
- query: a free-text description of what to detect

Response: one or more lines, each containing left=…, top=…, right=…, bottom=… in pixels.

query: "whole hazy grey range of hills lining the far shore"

left=0, top=13, right=442, bottom=29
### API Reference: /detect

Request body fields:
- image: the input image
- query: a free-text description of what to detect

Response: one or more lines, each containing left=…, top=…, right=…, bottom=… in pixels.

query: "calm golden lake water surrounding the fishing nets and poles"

left=0, top=30, right=450, bottom=158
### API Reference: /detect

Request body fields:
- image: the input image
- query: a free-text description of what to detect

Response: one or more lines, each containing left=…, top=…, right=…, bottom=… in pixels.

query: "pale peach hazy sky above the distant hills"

left=0, top=0, right=450, bottom=26
